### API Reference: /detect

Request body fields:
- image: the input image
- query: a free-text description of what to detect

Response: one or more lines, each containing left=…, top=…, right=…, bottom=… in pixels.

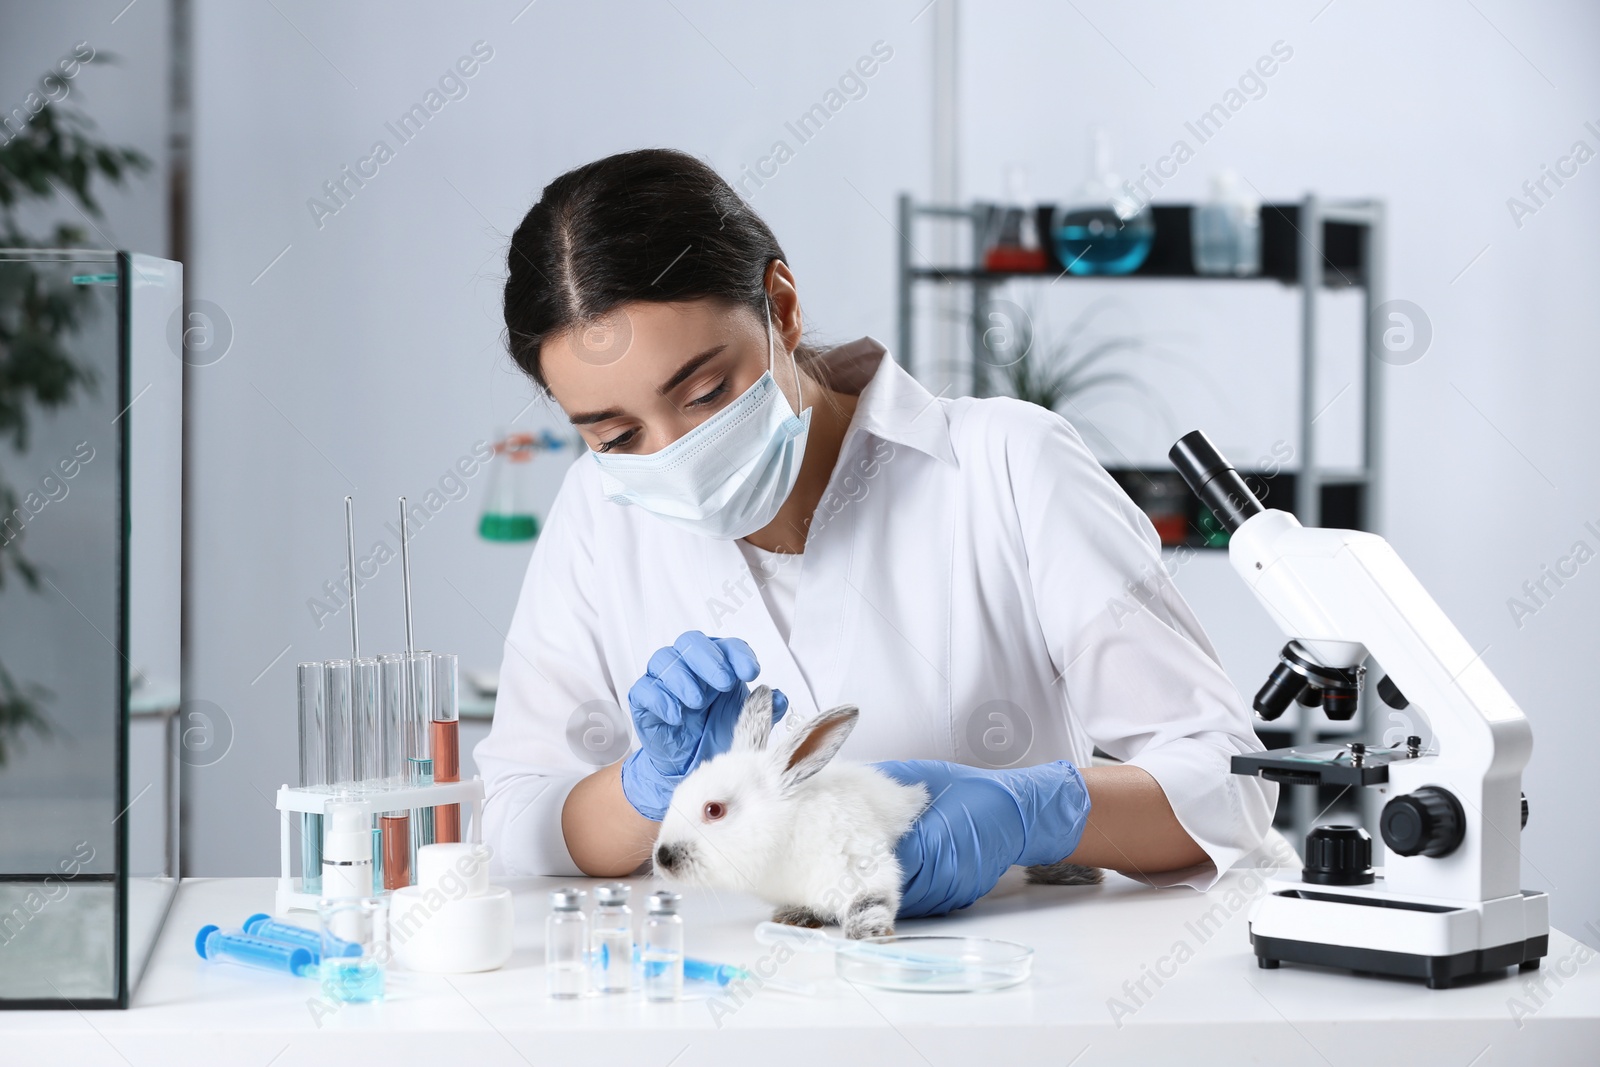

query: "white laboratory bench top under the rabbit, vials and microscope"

left=0, top=869, right=1600, bottom=1067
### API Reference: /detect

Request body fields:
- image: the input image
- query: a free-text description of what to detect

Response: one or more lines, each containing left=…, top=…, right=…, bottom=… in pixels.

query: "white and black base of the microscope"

left=1250, top=872, right=1550, bottom=989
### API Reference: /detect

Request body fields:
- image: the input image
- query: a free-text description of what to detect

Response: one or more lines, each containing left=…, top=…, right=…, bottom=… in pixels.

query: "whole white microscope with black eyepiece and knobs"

left=1168, top=430, right=1550, bottom=989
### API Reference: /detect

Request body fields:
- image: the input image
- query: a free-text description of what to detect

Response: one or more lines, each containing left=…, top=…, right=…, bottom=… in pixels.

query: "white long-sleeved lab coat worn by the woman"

left=475, top=338, right=1277, bottom=889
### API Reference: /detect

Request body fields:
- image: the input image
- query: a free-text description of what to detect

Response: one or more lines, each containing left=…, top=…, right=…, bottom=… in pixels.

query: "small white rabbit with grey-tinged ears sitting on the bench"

left=654, top=686, right=928, bottom=937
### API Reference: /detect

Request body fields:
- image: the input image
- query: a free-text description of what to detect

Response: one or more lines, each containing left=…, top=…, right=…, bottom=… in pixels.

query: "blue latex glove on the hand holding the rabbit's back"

left=875, top=760, right=1090, bottom=918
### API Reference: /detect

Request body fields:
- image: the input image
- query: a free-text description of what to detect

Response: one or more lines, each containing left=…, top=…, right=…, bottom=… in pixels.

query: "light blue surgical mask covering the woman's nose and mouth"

left=594, top=294, right=811, bottom=541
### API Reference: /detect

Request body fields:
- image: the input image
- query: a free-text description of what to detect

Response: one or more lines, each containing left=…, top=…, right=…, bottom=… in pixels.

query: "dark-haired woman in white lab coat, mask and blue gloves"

left=477, top=150, right=1277, bottom=915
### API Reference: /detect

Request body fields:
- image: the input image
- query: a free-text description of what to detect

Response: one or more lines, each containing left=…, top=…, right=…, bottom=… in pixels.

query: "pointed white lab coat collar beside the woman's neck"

left=822, top=338, right=955, bottom=467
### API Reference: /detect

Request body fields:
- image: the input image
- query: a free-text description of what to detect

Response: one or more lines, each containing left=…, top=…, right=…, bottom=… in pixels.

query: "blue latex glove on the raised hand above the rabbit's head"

left=622, top=630, right=789, bottom=822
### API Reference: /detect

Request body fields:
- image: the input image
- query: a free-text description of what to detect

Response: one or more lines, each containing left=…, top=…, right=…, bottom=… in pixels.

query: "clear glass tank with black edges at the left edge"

left=0, top=250, right=184, bottom=1008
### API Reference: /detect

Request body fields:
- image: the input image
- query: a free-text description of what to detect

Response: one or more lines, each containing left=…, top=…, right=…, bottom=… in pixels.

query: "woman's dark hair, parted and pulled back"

left=504, top=149, right=816, bottom=387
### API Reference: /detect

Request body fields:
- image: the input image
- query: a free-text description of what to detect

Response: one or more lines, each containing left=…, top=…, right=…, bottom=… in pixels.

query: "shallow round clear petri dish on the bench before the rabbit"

left=834, top=934, right=1034, bottom=993
